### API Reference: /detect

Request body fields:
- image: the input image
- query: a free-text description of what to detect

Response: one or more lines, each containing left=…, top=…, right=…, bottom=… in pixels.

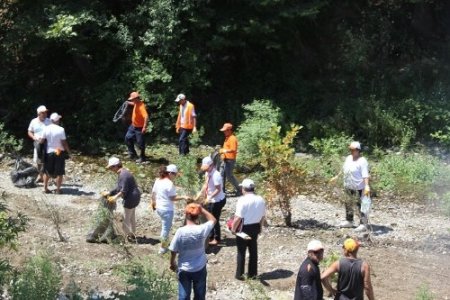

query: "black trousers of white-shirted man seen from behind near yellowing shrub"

left=235, top=223, right=261, bottom=278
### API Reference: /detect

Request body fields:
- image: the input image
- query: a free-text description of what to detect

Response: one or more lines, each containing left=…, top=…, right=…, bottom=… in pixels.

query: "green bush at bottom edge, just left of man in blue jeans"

left=119, top=259, right=175, bottom=300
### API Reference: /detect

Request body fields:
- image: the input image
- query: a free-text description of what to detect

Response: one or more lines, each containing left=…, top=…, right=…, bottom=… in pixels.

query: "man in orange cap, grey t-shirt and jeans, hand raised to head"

left=169, top=203, right=216, bottom=300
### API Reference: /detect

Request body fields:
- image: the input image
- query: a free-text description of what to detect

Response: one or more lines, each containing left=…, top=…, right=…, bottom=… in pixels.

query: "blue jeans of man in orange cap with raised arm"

left=178, top=266, right=207, bottom=300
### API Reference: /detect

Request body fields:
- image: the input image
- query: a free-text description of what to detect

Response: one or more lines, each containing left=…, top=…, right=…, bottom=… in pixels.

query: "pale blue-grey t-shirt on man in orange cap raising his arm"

left=169, top=221, right=214, bottom=272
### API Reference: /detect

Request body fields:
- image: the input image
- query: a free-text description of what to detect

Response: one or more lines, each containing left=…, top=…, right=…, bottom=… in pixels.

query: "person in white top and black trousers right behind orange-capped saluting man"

left=199, top=156, right=227, bottom=246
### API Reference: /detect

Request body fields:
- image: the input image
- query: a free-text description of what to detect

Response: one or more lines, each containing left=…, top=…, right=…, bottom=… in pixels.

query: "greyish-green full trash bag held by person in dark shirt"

left=86, top=197, right=121, bottom=243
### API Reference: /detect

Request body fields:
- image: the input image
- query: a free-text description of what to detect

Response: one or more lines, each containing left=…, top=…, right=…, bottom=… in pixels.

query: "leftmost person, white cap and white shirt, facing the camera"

left=28, top=105, right=51, bottom=182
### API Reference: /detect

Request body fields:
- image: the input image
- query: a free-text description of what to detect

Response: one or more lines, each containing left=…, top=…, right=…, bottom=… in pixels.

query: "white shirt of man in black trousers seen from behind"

left=235, top=193, right=266, bottom=225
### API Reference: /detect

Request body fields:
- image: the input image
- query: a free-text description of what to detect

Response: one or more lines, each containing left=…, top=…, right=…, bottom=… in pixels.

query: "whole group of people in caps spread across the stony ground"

left=28, top=92, right=374, bottom=300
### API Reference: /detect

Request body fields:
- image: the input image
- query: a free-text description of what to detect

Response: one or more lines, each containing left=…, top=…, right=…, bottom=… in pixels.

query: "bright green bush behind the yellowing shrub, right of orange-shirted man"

left=236, top=100, right=281, bottom=165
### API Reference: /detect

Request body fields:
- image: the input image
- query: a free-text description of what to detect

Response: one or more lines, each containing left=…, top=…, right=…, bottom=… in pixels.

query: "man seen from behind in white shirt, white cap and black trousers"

left=231, top=178, right=266, bottom=280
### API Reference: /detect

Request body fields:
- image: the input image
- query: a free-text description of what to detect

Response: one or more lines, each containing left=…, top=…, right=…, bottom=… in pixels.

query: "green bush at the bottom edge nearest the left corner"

left=11, top=253, right=61, bottom=300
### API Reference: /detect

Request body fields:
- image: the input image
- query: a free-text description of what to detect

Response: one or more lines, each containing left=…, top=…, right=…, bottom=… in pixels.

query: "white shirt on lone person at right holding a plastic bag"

left=342, top=155, right=369, bottom=190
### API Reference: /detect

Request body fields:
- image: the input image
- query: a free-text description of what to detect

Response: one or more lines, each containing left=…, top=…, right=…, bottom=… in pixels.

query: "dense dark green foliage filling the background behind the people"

left=0, top=0, right=450, bottom=150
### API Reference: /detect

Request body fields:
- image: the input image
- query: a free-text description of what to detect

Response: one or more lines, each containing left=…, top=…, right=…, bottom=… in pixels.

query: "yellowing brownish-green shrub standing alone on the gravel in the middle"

left=259, top=125, right=305, bottom=226
